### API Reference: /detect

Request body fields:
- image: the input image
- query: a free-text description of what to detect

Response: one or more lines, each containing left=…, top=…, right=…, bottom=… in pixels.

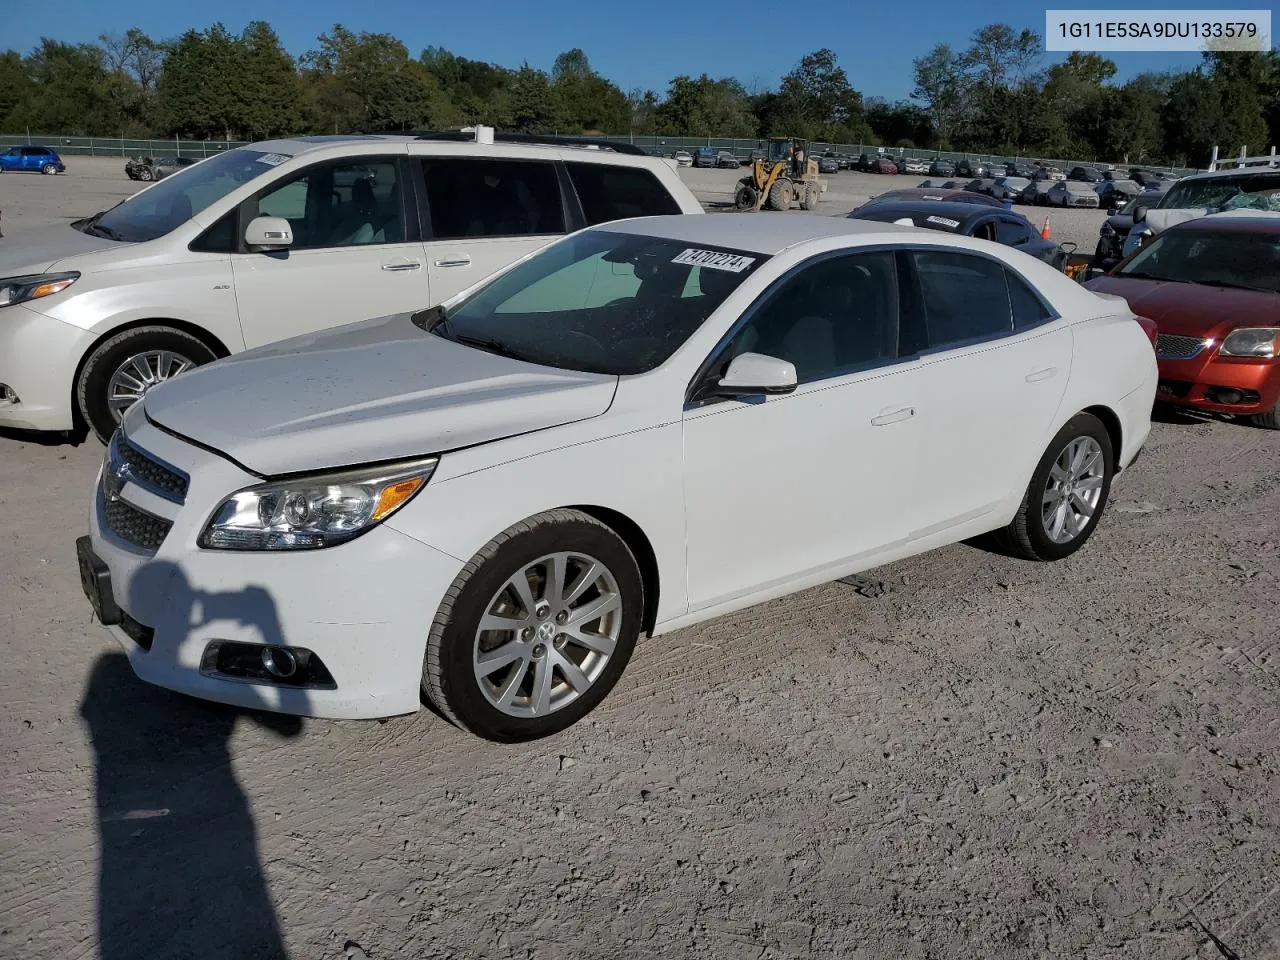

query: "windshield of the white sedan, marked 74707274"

left=430, top=230, right=768, bottom=375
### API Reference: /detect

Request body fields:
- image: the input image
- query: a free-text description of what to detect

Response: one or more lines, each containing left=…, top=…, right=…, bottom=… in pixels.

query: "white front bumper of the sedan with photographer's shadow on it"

left=78, top=417, right=462, bottom=719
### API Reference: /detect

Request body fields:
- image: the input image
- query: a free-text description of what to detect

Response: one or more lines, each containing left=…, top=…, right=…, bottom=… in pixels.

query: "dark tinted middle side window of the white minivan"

left=422, top=157, right=564, bottom=239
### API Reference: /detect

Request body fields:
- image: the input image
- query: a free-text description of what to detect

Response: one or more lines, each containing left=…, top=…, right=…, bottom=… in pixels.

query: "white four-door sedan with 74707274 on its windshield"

left=77, top=214, right=1156, bottom=741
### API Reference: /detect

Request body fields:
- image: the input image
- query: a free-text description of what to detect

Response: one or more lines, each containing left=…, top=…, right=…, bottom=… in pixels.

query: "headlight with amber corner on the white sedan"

left=198, top=457, right=439, bottom=550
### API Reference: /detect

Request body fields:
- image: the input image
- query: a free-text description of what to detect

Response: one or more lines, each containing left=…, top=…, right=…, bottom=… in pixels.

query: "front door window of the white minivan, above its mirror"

left=257, top=157, right=404, bottom=250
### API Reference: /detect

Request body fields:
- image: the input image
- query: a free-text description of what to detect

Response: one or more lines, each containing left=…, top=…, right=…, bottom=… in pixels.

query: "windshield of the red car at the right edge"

left=1117, top=230, right=1280, bottom=293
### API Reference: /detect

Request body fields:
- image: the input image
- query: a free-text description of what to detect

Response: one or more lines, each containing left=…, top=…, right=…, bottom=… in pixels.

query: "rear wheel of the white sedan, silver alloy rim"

left=997, top=413, right=1115, bottom=561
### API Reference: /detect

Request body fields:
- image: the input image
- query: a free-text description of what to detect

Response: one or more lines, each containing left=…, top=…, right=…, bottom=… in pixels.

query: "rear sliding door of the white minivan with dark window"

left=412, top=156, right=568, bottom=303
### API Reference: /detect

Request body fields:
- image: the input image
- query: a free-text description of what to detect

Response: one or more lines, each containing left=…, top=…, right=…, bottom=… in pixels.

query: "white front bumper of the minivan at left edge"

left=0, top=303, right=93, bottom=430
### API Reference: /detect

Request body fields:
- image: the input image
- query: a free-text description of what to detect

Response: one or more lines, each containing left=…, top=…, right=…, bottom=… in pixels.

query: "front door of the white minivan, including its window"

left=232, top=156, right=431, bottom=348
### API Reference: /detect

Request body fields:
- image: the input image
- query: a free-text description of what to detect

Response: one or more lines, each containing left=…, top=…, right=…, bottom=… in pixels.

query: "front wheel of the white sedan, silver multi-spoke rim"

left=422, top=509, right=644, bottom=742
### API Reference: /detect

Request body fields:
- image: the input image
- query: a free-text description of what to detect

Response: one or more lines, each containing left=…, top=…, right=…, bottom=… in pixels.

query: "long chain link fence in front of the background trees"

left=0, top=133, right=1197, bottom=177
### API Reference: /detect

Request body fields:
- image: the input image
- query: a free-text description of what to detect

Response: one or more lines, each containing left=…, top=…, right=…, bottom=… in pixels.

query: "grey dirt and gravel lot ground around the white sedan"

left=0, top=150, right=1280, bottom=960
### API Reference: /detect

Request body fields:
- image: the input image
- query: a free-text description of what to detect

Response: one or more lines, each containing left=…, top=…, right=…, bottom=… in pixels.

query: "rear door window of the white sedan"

left=911, top=251, right=1012, bottom=349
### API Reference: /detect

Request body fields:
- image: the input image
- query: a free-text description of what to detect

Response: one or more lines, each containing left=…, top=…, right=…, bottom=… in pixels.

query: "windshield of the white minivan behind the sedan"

left=88, top=148, right=289, bottom=242
